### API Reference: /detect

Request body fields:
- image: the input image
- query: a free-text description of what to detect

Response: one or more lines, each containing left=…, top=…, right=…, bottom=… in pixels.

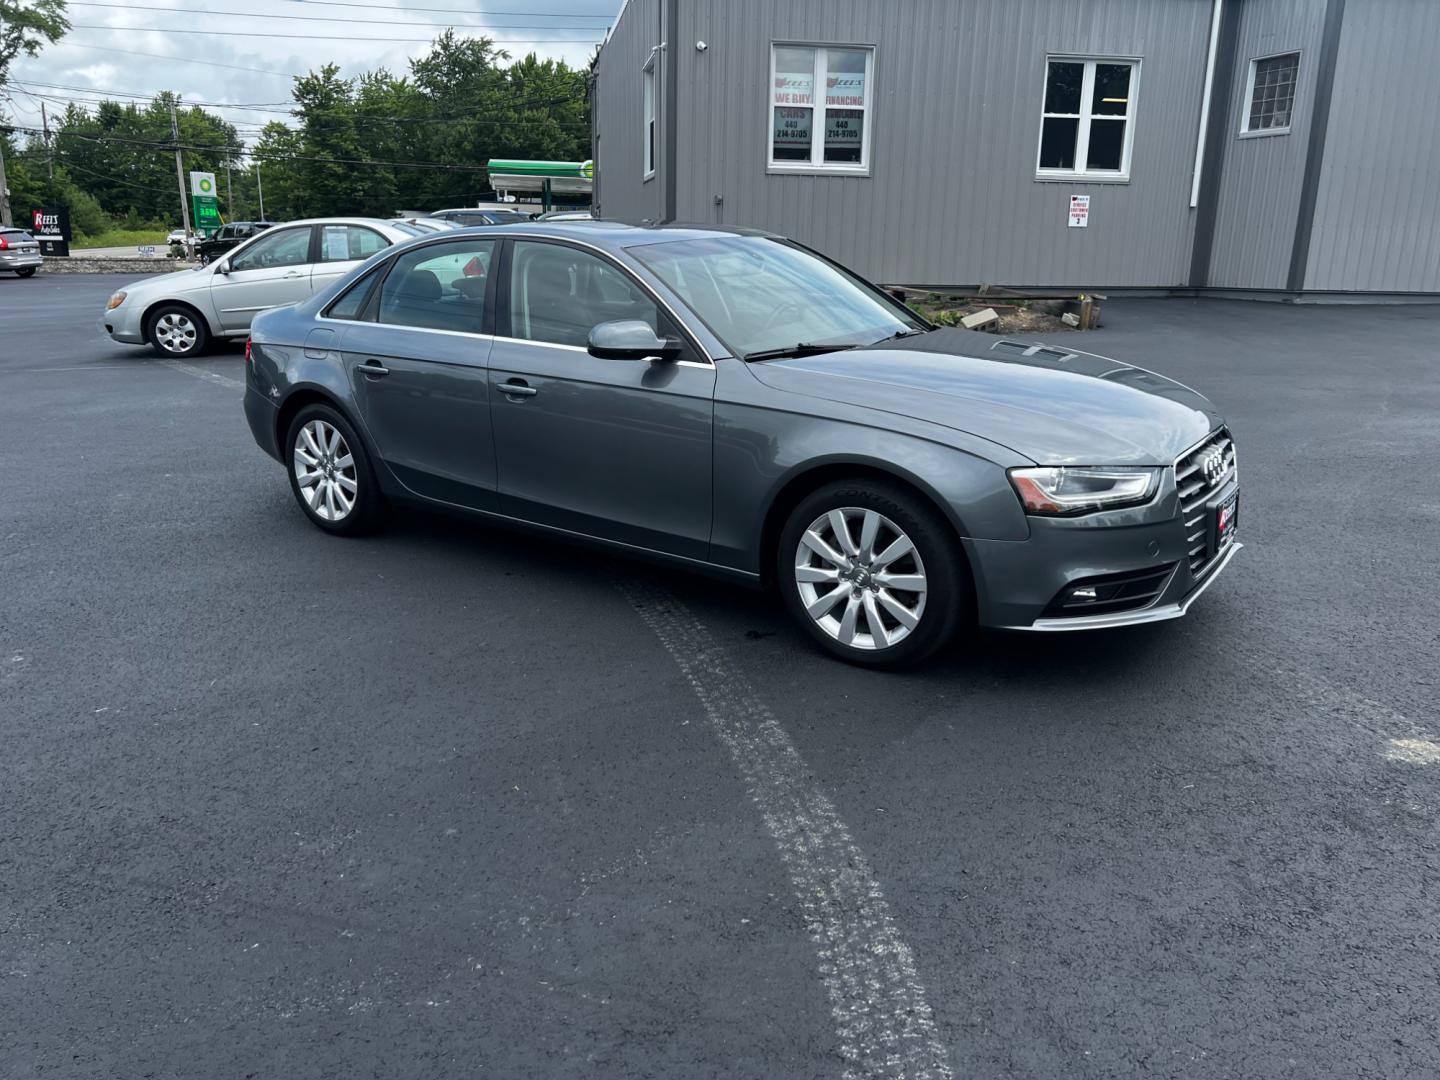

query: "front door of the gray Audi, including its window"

left=490, top=240, right=716, bottom=559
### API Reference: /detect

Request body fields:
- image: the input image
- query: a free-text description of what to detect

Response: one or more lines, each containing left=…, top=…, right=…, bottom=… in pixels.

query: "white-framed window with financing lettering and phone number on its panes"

left=768, top=43, right=874, bottom=176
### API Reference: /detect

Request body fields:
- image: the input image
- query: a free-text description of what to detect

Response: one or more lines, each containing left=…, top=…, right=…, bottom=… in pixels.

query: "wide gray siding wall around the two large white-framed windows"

left=613, top=0, right=1211, bottom=287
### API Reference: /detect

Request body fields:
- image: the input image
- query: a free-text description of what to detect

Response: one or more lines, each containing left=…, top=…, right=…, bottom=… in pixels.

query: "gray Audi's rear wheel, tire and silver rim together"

left=285, top=405, right=383, bottom=536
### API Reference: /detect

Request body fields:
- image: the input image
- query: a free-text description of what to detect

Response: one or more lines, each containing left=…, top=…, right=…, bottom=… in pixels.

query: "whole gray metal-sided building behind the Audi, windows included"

left=593, top=0, right=1440, bottom=300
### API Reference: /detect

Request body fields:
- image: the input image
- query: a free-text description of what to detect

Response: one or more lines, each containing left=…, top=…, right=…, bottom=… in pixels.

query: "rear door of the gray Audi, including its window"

left=341, top=238, right=498, bottom=511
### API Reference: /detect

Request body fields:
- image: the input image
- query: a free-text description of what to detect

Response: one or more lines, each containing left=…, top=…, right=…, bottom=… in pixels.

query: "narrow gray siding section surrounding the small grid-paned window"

left=1207, top=0, right=1325, bottom=289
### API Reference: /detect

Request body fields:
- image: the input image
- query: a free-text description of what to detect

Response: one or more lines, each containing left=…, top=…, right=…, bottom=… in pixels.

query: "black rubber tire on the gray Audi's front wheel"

left=775, top=478, right=972, bottom=668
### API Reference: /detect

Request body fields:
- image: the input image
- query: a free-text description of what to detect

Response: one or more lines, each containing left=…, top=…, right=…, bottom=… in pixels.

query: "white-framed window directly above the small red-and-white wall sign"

left=1035, top=56, right=1140, bottom=180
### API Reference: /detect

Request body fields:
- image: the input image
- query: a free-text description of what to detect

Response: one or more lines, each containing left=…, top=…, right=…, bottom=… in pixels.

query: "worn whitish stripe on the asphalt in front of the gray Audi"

left=619, top=582, right=952, bottom=1080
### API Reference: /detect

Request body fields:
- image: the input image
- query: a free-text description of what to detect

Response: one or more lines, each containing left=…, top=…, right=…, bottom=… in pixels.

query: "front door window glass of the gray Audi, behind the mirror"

left=510, top=240, right=660, bottom=348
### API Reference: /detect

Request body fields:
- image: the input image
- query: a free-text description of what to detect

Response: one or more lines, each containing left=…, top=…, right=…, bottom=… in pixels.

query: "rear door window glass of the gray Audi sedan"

left=379, top=239, right=495, bottom=334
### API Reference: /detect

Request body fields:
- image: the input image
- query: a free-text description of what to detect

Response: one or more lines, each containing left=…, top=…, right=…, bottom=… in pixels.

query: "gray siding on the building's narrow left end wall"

left=592, top=0, right=665, bottom=223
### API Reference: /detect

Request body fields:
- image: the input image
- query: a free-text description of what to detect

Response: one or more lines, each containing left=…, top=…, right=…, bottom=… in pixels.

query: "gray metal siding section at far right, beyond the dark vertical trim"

left=1305, top=0, right=1440, bottom=292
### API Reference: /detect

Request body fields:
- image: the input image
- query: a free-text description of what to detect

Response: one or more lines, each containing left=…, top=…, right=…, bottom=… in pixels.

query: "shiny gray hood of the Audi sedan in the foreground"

left=750, top=328, right=1220, bottom=465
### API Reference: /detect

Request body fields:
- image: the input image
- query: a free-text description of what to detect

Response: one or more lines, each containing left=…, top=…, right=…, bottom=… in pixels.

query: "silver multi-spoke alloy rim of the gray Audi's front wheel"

left=795, top=507, right=929, bottom=649
